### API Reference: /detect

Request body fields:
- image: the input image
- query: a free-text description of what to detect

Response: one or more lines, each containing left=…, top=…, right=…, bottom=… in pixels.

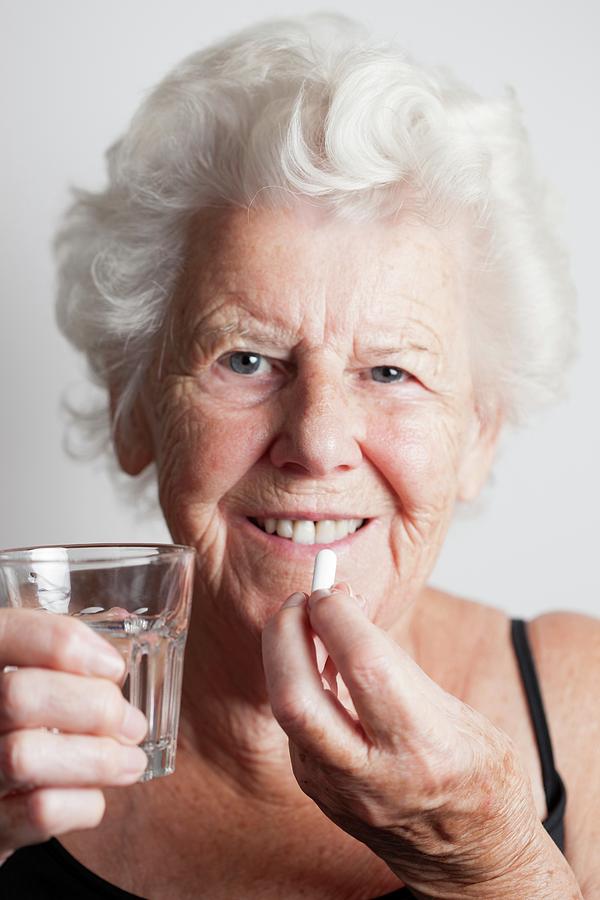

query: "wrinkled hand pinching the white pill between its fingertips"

left=263, top=585, right=540, bottom=897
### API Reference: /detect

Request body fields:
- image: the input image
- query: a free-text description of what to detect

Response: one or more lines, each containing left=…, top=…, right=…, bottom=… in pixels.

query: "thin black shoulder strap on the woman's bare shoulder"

left=511, top=619, right=567, bottom=850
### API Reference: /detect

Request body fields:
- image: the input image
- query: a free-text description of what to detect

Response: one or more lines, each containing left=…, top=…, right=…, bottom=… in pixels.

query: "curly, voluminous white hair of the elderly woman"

left=56, top=14, right=575, bottom=502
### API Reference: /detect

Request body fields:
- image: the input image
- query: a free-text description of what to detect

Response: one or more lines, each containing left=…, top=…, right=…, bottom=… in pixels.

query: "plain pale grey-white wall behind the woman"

left=0, top=0, right=600, bottom=618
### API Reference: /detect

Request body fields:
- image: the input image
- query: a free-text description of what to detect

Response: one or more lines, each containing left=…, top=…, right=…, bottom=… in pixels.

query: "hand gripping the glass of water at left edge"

left=0, top=609, right=147, bottom=863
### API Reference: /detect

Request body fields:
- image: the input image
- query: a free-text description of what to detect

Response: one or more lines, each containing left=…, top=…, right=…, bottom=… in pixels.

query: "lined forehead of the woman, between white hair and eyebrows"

left=181, top=209, right=466, bottom=340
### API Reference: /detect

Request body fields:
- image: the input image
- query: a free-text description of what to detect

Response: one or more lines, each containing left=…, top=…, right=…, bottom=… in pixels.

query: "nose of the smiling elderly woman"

left=270, top=374, right=363, bottom=476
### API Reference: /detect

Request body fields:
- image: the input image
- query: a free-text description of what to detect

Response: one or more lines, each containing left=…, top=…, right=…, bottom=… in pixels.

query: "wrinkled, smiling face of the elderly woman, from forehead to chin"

left=129, top=209, right=494, bottom=632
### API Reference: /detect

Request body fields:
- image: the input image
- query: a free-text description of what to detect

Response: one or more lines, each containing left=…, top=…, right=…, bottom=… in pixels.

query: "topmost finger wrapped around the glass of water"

left=0, top=609, right=125, bottom=681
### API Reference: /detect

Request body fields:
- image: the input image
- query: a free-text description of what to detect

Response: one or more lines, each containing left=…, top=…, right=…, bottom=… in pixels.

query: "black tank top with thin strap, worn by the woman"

left=0, top=619, right=567, bottom=900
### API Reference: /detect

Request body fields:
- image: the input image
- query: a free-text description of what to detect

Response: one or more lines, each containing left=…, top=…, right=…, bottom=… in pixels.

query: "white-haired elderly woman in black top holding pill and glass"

left=0, top=16, right=600, bottom=900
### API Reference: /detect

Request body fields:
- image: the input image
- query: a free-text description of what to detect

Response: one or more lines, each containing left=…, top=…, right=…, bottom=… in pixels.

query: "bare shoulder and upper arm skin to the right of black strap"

left=528, top=612, right=600, bottom=897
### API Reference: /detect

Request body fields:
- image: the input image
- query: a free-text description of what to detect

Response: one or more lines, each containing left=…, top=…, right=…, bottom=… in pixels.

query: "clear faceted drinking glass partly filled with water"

left=0, top=544, right=195, bottom=781
